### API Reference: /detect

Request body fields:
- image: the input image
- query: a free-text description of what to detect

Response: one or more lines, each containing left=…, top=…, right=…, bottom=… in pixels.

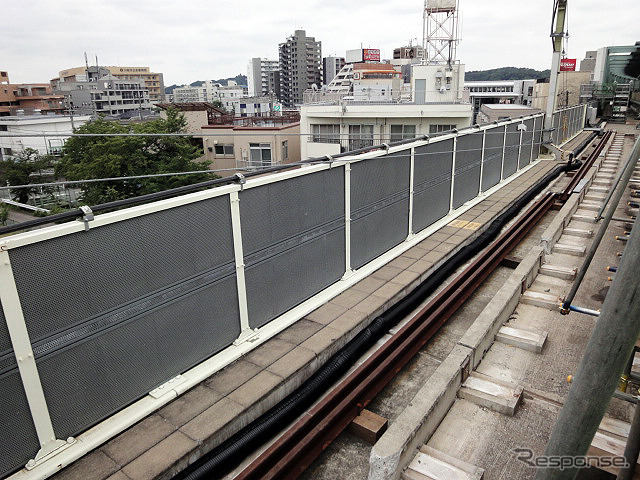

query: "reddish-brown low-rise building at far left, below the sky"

left=0, top=72, right=65, bottom=116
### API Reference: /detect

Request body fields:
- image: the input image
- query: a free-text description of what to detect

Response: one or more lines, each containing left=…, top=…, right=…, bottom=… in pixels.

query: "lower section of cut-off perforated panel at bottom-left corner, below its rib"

left=0, top=368, right=39, bottom=478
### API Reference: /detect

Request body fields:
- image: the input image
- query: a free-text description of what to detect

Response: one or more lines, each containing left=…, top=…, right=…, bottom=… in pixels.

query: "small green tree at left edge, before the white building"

left=0, top=148, right=53, bottom=203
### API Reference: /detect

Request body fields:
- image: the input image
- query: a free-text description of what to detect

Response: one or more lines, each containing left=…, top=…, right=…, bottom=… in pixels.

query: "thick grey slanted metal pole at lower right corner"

left=535, top=158, right=640, bottom=480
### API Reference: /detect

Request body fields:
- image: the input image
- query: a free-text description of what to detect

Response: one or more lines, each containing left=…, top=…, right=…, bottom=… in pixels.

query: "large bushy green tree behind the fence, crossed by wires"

left=56, top=109, right=215, bottom=205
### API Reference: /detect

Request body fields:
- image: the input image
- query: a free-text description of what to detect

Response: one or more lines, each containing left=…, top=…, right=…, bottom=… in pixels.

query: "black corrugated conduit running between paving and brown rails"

left=176, top=158, right=581, bottom=480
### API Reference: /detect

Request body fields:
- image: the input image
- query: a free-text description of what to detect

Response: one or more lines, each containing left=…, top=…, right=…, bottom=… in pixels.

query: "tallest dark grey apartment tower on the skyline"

left=279, top=30, right=322, bottom=108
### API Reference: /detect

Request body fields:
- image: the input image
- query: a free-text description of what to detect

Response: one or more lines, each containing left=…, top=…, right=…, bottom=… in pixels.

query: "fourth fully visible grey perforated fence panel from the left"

left=413, top=140, right=453, bottom=233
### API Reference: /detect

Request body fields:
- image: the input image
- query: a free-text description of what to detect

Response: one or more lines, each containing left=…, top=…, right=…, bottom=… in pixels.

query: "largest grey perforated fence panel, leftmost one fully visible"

left=10, top=197, right=240, bottom=438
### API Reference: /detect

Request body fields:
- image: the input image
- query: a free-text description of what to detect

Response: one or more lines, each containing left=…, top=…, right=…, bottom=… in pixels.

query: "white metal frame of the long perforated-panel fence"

left=0, top=114, right=568, bottom=480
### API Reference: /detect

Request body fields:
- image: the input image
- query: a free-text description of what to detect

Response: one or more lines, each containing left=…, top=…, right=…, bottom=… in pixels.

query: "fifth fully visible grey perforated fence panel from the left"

left=453, top=132, right=483, bottom=208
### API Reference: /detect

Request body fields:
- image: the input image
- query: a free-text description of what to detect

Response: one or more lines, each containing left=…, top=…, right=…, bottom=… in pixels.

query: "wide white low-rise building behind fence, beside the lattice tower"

left=300, top=63, right=472, bottom=159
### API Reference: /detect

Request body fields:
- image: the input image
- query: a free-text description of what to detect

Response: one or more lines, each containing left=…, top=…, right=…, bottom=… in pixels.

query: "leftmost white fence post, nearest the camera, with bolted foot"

left=0, top=246, right=67, bottom=465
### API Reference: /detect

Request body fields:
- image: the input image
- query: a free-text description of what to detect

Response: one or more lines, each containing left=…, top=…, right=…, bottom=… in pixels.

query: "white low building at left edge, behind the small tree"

left=0, top=114, right=91, bottom=160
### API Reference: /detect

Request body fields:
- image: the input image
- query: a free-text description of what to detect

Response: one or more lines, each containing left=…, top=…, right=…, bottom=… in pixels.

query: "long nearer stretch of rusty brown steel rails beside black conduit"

left=236, top=193, right=557, bottom=480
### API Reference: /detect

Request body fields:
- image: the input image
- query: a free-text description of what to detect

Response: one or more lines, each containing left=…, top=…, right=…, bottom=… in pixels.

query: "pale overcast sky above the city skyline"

left=0, top=0, right=640, bottom=86
